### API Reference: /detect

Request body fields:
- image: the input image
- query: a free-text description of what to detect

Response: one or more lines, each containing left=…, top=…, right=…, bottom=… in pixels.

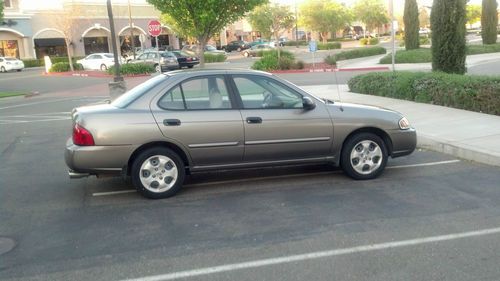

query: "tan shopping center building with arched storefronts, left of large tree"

left=0, top=0, right=179, bottom=59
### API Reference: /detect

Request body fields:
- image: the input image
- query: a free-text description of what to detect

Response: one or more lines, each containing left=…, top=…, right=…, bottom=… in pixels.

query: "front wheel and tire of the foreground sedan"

left=340, top=133, right=388, bottom=180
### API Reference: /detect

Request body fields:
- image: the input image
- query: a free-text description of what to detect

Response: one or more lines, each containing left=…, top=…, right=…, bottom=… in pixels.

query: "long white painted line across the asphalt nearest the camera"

left=123, top=227, right=500, bottom=281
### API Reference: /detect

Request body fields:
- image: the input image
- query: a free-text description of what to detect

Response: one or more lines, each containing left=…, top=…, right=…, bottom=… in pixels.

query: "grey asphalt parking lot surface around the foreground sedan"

left=0, top=95, right=500, bottom=280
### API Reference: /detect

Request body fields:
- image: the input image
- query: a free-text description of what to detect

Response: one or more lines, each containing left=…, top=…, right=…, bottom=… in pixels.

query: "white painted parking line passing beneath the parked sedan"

left=92, top=159, right=460, bottom=196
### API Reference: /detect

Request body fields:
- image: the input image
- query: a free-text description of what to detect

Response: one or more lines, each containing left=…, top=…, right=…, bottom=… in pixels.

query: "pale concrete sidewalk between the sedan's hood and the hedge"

left=301, top=85, right=500, bottom=166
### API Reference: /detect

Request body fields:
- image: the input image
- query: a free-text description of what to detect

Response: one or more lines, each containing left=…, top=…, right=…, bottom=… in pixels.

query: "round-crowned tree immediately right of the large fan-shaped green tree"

left=248, top=4, right=295, bottom=40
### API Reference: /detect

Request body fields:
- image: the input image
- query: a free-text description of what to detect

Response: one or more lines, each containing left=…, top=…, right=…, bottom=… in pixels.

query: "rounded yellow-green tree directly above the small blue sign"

left=300, top=0, right=351, bottom=43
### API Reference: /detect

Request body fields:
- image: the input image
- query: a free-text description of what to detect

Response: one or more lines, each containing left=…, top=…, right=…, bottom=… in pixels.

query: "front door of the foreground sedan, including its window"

left=233, top=75, right=333, bottom=162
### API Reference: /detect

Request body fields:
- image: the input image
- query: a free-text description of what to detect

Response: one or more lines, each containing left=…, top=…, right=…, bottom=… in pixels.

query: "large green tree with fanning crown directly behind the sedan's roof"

left=148, top=0, right=266, bottom=67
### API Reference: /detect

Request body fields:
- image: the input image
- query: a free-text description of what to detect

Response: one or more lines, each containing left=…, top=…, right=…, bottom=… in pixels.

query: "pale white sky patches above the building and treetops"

left=21, top=0, right=488, bottom=12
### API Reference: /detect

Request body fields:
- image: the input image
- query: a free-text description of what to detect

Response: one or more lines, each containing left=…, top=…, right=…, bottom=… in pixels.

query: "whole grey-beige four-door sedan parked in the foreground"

left=65, top=70, right=416, bottom=198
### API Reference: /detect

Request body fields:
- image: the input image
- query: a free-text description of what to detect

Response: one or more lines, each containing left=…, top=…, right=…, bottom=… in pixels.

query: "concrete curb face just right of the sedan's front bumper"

left=417, top=135, right=500, bottom=167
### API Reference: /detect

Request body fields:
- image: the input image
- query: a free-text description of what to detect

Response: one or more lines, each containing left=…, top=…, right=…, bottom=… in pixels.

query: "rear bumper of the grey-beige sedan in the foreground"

left=64, top=138, right=137, bottom=175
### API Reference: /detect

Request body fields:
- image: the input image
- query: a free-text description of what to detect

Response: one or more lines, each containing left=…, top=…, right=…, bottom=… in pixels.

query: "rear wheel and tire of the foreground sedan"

left=131, top=147, right=185, bottom=199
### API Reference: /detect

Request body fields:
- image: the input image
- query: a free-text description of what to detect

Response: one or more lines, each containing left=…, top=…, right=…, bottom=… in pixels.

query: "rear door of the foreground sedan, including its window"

left=152, top=75, right=244, bottom=168
